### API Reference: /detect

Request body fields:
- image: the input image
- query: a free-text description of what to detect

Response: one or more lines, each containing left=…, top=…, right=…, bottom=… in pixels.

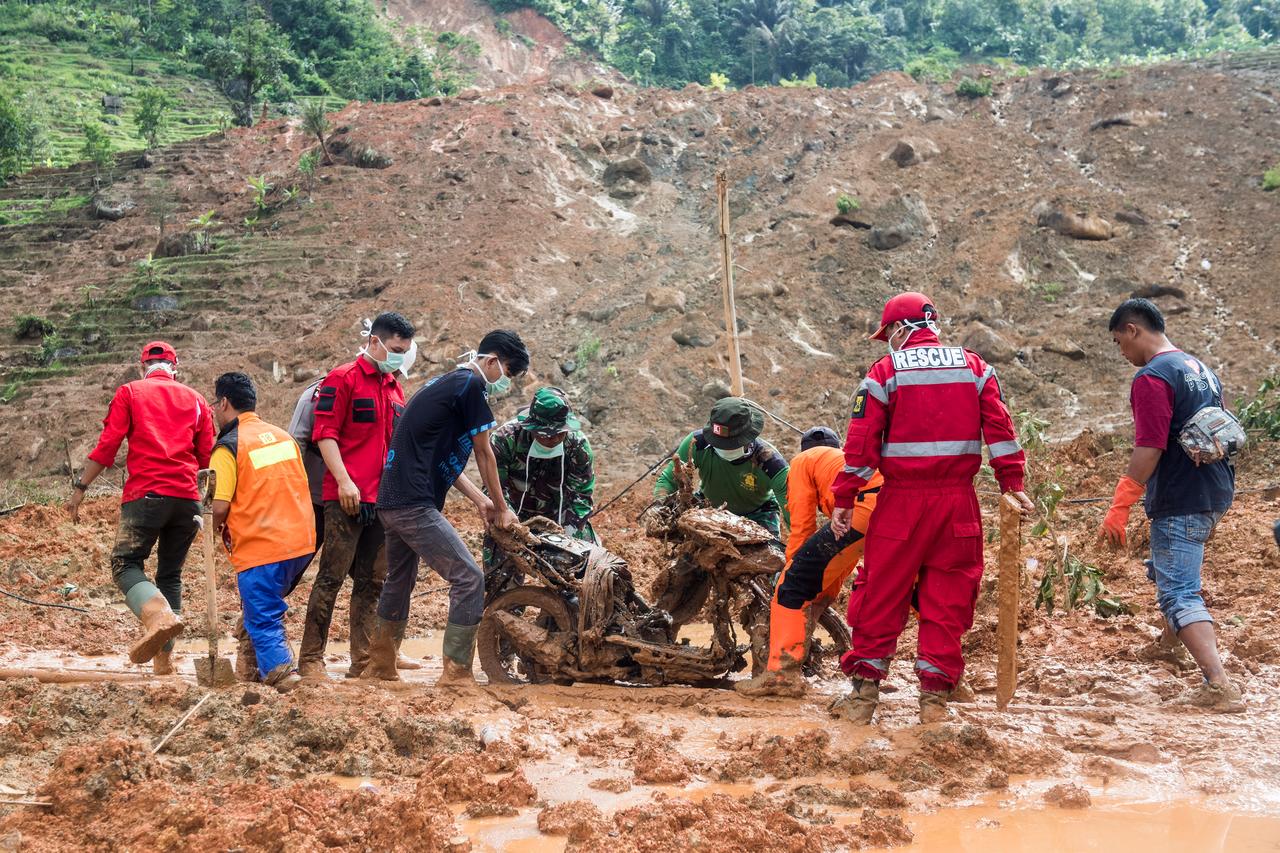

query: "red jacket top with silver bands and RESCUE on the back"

left=832, top=330, right=1027, bottom=507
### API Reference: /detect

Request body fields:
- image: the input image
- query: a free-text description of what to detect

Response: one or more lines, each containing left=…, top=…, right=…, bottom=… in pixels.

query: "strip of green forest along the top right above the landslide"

left=489, top=0, right=1280, bottom=87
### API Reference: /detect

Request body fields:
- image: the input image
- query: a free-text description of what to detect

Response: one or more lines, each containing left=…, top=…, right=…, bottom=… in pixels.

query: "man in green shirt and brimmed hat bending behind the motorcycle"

left=653, top=397, right=790, bottom=537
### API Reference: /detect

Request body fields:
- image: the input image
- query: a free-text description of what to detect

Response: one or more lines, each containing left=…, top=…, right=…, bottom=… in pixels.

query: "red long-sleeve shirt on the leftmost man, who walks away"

left=88, top=370, right=214, bottom=503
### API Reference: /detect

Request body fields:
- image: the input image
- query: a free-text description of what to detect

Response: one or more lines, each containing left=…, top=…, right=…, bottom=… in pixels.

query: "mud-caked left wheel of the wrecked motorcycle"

left=476, top=587, right=577, bottom=684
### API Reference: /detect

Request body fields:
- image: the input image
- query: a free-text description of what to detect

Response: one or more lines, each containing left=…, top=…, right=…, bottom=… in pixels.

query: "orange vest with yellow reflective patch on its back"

left=218, top=411, right=316, bottom=571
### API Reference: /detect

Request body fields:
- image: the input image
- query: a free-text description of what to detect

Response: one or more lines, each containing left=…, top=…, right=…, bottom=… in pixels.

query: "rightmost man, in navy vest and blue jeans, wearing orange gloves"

left=1098, top=298, right=1244, bottom=713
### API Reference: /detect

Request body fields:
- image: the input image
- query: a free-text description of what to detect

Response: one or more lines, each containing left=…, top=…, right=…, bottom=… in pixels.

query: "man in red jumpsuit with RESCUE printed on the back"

left=831, top=292, right=1033, bottom=724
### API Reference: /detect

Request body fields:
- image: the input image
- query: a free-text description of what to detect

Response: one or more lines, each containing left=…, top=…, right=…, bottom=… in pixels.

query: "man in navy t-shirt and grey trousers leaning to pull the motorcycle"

left=365, top=329, right=529, bottom=684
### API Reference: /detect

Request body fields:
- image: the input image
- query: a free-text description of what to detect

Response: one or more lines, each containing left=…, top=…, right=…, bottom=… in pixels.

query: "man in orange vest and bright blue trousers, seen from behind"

left=210, top=373, right=316, bottom=693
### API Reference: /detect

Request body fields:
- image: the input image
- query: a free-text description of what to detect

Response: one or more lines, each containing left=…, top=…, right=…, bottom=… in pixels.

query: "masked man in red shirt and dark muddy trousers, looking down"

left=298, top=311, right=413, bottom=678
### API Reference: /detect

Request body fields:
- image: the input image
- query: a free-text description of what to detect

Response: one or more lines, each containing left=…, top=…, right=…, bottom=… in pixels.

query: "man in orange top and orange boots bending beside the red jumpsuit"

left=733, top=427, right=884, bottom=697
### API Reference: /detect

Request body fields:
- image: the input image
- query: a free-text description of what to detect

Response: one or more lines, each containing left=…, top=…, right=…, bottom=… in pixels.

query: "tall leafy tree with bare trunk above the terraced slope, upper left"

left=204, top=10, right=292, bottom=127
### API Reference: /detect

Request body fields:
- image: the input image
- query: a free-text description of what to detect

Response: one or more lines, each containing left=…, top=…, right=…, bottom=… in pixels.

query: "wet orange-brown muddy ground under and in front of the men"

left=0, top=434, right=1280, bottom=850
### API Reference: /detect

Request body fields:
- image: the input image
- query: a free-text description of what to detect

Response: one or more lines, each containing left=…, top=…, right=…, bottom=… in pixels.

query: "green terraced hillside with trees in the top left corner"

left=0, top=0, right=479, bottom=175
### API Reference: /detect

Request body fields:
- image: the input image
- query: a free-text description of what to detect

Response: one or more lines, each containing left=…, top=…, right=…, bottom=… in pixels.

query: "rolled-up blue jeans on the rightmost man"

left=1147, top=512, right=1222, bottom=631
